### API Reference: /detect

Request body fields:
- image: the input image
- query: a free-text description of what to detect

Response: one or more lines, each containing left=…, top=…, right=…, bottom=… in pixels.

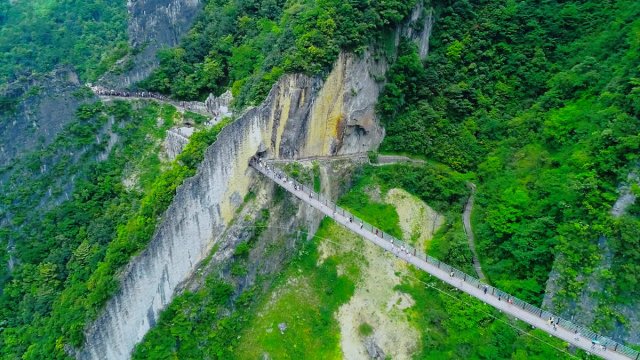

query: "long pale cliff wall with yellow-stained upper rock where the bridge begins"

left=77, top=7, right=432, bottom=359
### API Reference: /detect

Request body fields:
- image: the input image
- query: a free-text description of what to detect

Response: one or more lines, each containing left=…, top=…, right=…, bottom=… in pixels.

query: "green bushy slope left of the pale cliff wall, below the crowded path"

left=0, top=102, right=228, bottom=358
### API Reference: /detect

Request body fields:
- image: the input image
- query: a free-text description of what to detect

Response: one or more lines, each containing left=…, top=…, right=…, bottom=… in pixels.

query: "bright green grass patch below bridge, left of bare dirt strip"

left=235, top=220, right=357, bottom=359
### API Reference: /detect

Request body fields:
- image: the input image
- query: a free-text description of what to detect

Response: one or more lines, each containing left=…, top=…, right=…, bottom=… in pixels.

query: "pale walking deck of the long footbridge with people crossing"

left=250, top=158, right=640, bottom=360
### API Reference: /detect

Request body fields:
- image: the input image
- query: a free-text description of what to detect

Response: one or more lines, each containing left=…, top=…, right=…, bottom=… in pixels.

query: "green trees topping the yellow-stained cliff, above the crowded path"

left=142, top=0, right=417, bottom=105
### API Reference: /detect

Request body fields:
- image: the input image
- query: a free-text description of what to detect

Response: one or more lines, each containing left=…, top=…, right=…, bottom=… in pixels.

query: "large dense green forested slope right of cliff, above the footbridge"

left=379, top=0, right=640, bottom=329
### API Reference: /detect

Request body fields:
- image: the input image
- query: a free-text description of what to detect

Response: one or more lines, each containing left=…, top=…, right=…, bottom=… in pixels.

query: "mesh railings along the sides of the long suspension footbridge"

left=251, top=159, right=640, bottom=360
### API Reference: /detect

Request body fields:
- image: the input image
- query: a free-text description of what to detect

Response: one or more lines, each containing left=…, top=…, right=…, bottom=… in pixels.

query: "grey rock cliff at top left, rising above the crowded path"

left=100, top=0, right=202, bottom=89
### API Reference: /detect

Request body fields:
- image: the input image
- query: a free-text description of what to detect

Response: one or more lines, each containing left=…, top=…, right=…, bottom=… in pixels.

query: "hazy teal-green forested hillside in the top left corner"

left=0, top=0, right=128, bottom=82
